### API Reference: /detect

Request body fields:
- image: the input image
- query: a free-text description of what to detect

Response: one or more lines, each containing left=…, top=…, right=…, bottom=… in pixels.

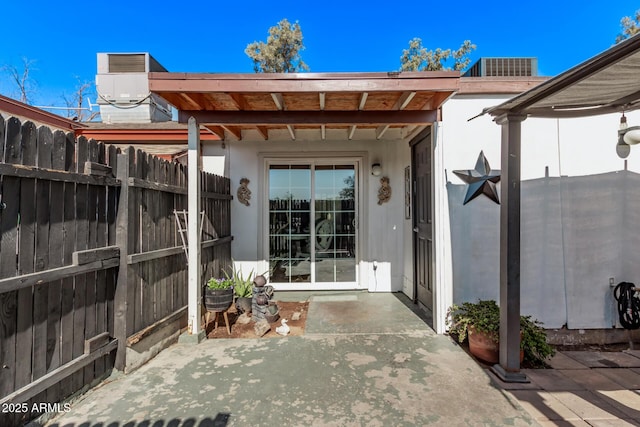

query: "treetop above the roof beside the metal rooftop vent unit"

left=400, top=37, right=476, bottom=71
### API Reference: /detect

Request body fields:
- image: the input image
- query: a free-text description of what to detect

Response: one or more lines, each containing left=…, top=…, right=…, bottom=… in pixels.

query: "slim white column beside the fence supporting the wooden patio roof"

left=187, top=117, right=204, bottom=335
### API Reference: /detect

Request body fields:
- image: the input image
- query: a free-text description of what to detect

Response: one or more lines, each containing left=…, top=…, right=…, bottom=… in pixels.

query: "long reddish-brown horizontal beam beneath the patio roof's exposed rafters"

left=178, top=110, right=437, bottom=126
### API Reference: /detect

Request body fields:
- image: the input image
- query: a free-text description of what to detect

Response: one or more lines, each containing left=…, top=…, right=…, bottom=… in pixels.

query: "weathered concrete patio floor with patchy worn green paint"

left=37, top=292, right=537, bottom=427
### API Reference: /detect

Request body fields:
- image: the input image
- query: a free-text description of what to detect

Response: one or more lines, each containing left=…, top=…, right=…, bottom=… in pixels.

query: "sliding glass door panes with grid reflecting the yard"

left=269, top=164, right=357, bottom=287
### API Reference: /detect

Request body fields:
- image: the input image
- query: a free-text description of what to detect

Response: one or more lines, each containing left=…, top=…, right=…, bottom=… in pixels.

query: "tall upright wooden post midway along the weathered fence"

left=113, top=150, right=133, bottom=371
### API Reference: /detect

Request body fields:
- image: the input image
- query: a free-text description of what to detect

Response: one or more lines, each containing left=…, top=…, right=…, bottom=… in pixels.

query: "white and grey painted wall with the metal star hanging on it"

left=436, top=96, right=640, bottom=329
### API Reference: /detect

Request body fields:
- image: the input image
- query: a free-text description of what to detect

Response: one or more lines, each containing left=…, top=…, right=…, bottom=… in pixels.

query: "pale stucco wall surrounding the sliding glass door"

left=203, top=132, right=410, bottom=292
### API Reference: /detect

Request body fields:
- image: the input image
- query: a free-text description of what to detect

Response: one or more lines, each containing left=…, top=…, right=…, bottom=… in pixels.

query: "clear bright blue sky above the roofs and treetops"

left=0, top=0, right=640, bottom=110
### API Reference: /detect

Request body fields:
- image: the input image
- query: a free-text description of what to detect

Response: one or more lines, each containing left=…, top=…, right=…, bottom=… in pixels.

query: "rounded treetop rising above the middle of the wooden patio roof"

left=244, top=18, right=309, bottom=73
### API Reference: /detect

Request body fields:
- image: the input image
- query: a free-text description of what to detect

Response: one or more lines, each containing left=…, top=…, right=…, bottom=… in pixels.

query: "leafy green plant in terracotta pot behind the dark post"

left=447, top=300, right=555, bottom=367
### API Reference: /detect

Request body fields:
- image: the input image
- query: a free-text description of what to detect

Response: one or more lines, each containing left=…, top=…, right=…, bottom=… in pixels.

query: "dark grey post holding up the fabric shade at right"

left=492, top=114, right=529, bottom=382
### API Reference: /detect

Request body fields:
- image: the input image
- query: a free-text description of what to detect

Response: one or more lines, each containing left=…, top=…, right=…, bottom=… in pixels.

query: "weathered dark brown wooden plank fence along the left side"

left=0, top=116, right=231, bottom=426
